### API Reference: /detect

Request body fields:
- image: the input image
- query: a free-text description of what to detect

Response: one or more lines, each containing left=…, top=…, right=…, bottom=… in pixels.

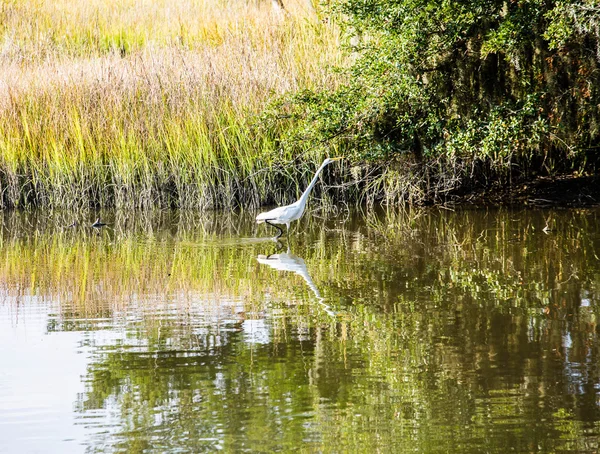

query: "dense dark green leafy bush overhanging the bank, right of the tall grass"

left=280, top=0, right=600, bottom=200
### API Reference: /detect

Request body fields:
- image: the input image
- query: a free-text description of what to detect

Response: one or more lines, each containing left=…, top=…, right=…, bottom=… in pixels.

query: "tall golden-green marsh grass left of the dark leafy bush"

left=0, top=0, right=342, bottom=208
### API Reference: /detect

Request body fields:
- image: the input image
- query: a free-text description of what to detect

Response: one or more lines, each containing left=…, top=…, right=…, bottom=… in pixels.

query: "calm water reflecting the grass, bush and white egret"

left=0, top=209, right=600, bottom=453
